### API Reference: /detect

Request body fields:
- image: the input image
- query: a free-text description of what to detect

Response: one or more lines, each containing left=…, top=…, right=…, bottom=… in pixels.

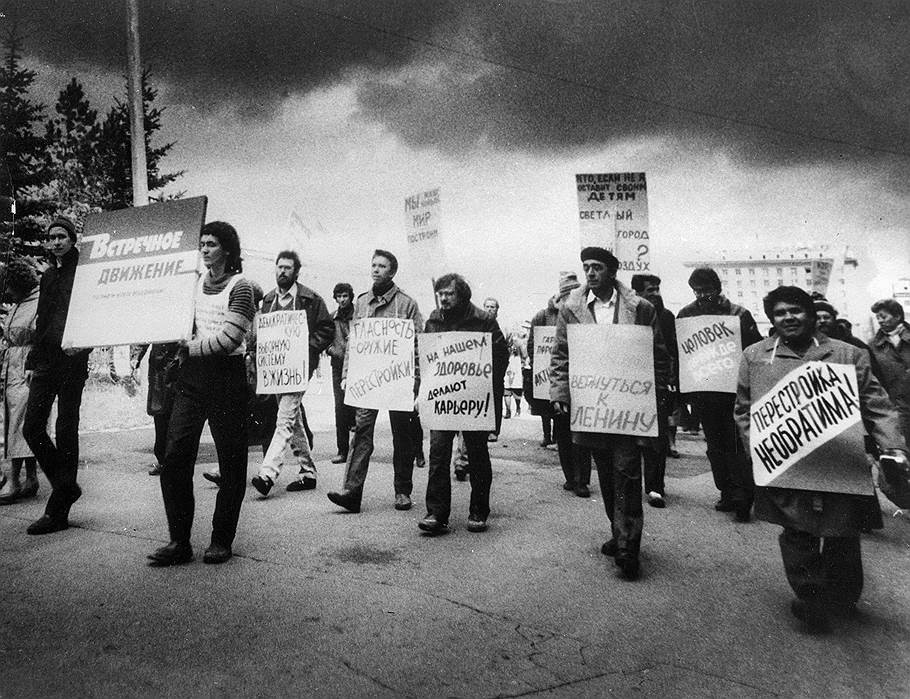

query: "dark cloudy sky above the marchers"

left=3, top=0, right=910, bottom=326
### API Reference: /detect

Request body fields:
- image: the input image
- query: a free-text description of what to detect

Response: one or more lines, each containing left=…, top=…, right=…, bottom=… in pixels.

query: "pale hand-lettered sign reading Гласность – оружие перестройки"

left=344, top=318, right=414, bottom=411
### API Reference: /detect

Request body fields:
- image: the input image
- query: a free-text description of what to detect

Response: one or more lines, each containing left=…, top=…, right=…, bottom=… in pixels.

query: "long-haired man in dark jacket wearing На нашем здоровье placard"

left=417, top=274, right=509, bottom=534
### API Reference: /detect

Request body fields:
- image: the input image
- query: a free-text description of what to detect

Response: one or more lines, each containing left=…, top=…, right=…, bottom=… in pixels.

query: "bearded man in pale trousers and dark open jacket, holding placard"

left=247, top=250, right=335, bottom=497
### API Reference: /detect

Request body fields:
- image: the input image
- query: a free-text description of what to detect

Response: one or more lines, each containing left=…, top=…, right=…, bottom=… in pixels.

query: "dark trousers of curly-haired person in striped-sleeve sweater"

left=161, top=356, right=249, bottom=546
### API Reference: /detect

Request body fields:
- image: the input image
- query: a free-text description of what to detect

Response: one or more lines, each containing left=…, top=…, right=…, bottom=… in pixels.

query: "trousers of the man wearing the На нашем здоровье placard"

left=427, top=430, right=493, bottom=523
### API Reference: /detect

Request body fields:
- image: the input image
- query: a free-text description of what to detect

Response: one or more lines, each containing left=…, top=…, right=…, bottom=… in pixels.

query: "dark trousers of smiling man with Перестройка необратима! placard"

left=779, top=528, right=863, bottom=607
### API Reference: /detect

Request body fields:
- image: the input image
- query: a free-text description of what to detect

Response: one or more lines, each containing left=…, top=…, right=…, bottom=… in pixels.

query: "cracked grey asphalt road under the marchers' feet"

left=0, top=397, right=910, bottom=697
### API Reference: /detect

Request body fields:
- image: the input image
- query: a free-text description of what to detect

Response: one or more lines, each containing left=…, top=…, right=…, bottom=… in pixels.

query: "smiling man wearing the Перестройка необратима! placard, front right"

left=736, top=286, right=907, bottom=630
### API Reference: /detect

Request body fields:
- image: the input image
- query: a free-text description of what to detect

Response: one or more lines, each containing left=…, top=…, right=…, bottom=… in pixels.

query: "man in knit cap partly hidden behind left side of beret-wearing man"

left=525, top=272, right=591, bottom=498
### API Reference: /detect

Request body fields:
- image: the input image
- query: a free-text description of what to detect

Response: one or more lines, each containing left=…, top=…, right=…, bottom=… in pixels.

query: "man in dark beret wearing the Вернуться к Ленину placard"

left=550, top=247, right=670, bottom=580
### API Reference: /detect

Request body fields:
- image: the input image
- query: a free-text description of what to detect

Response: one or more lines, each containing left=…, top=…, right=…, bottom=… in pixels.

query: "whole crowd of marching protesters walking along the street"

left=0, top=218, right=910, bottom=625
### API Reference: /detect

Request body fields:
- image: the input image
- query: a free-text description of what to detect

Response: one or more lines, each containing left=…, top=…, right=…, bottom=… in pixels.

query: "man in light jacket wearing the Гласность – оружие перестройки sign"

left=327, top=250, right=423, bottom=512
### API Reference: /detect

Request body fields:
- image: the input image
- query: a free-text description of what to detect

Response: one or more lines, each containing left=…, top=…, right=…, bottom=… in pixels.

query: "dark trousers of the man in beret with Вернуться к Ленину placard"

left=591, top=434, right=644, bottom=559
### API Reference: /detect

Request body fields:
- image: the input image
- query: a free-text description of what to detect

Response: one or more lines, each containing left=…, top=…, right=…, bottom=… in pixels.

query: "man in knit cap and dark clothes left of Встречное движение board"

left=22, top=218, right=91, bottom=534
